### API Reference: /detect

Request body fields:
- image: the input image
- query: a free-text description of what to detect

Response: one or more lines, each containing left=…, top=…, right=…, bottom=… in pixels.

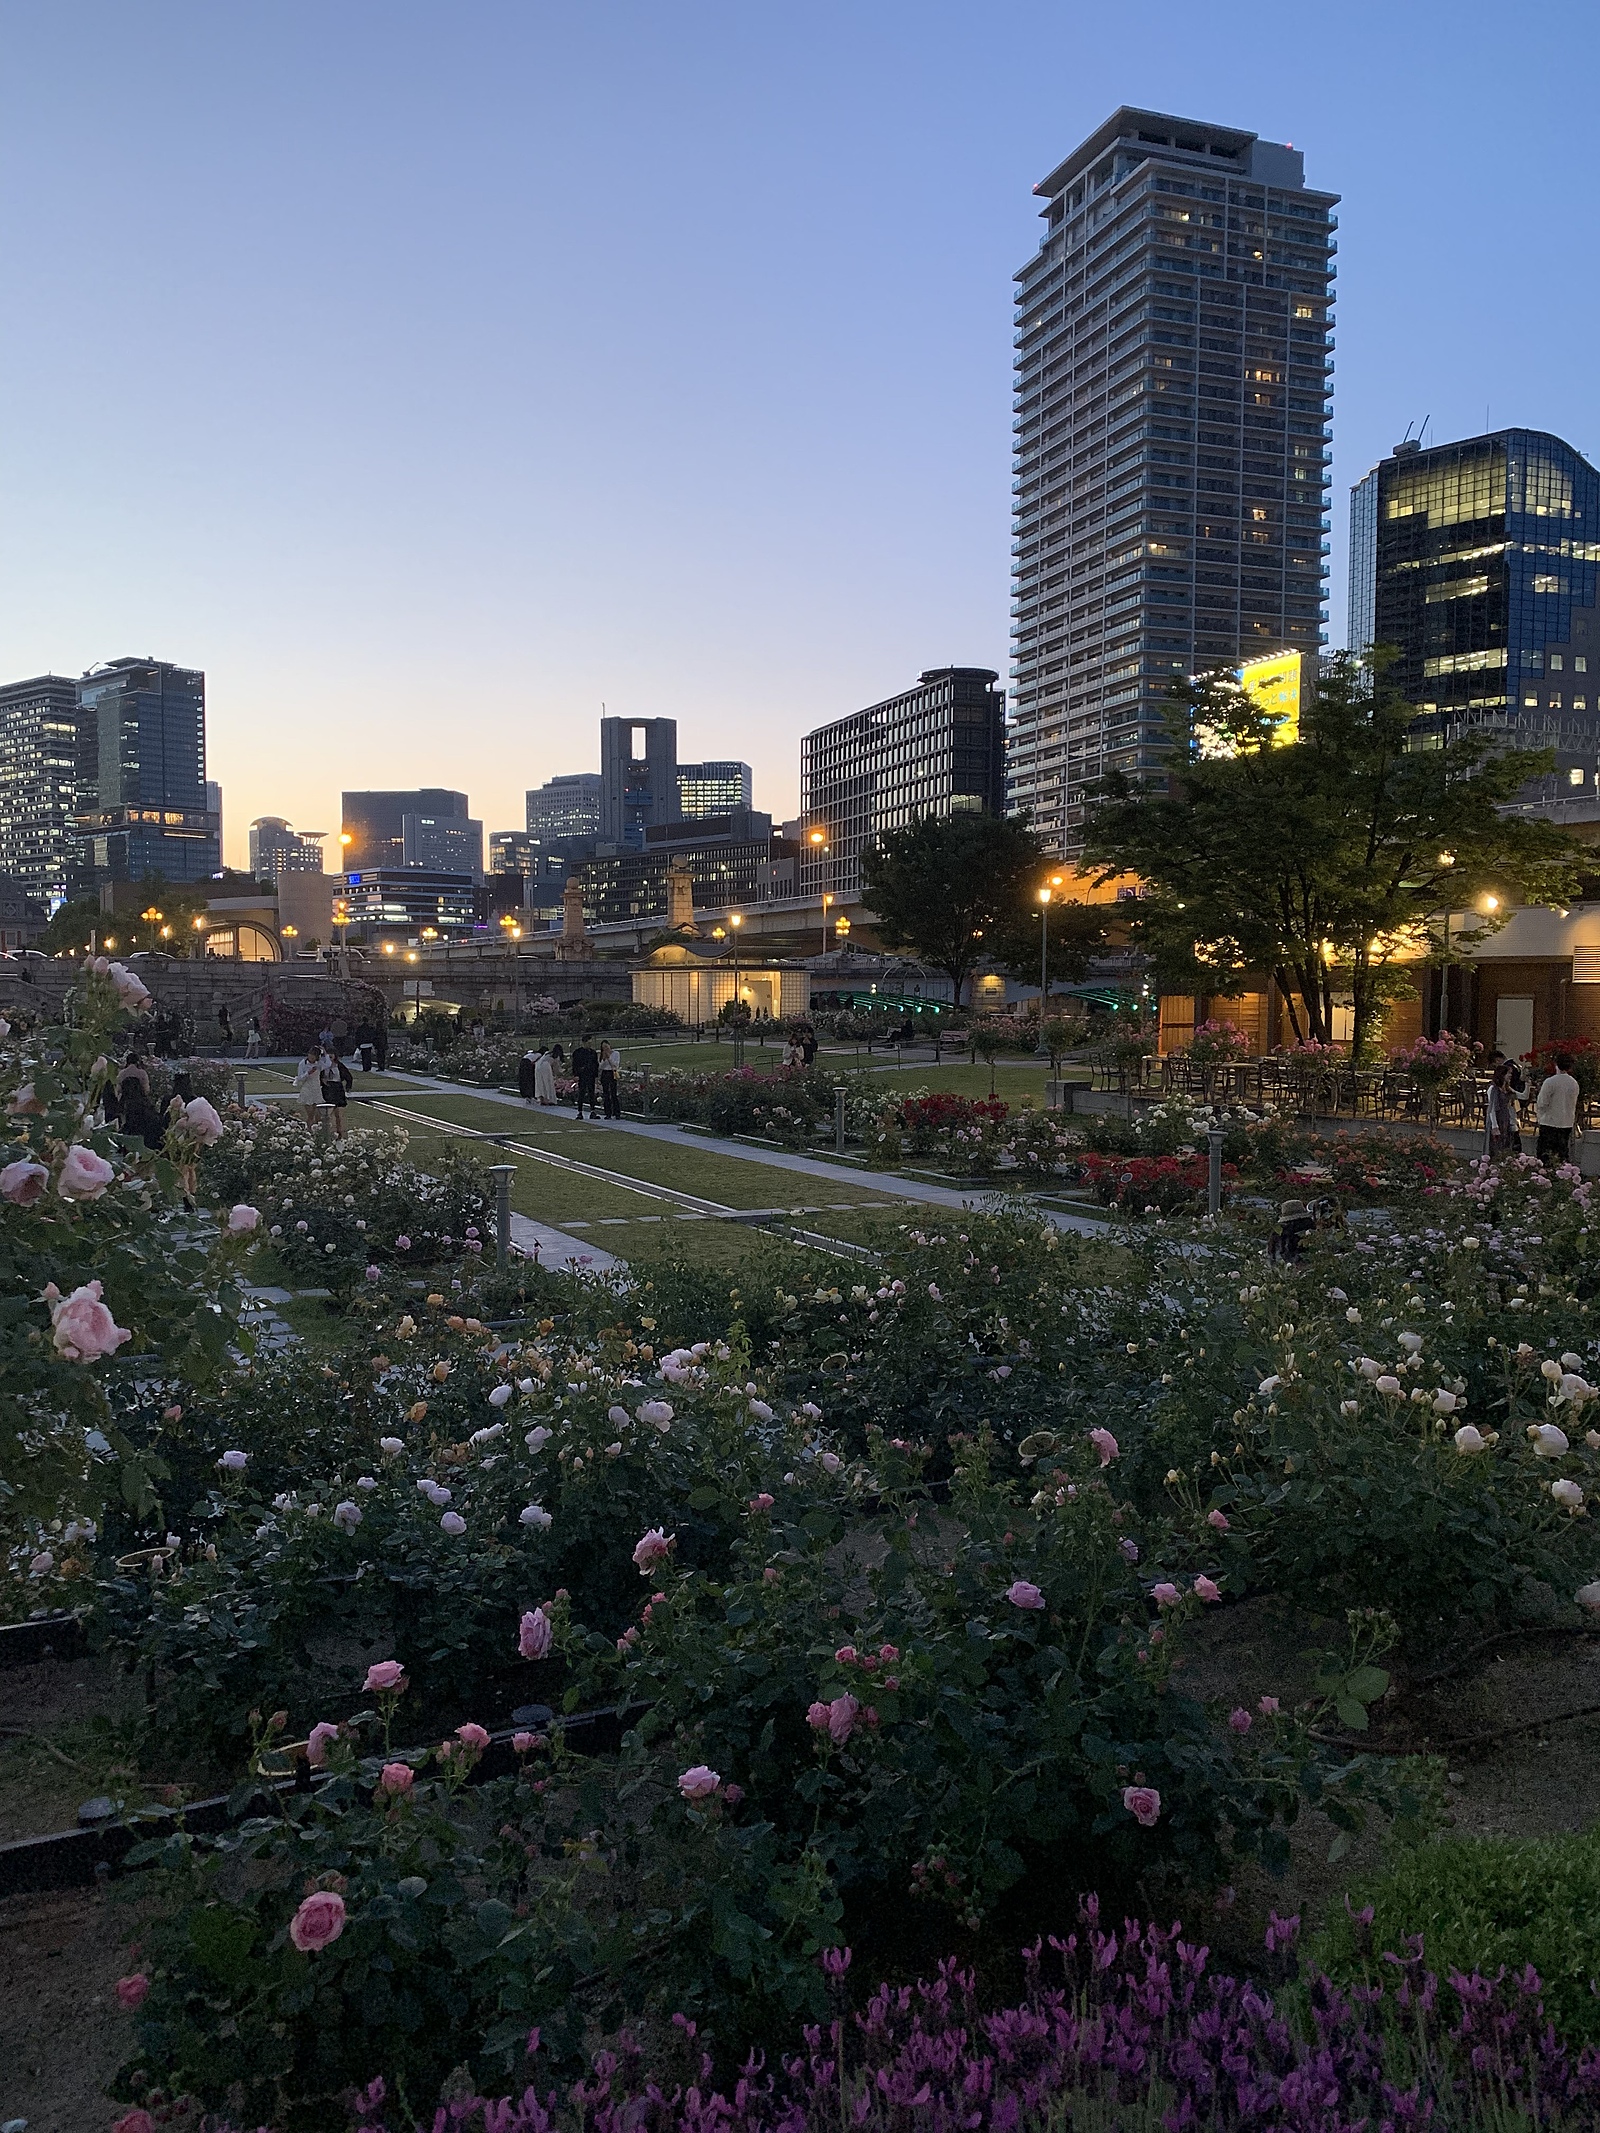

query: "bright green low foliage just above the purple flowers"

left=1316, top=1830, right=1600, bottom=2043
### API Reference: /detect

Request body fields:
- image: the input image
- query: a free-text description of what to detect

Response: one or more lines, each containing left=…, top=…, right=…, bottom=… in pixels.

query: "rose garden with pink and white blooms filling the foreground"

left=0, top=966, right=1600, bottom=2133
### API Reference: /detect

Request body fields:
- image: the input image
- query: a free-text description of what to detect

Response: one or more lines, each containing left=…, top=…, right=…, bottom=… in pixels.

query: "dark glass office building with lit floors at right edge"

left=1348, top=429, right=1600, bottom=804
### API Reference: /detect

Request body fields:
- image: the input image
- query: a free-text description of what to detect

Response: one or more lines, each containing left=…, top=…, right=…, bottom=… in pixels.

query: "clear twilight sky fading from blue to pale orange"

left=0, top=0, right=1600, bottom=864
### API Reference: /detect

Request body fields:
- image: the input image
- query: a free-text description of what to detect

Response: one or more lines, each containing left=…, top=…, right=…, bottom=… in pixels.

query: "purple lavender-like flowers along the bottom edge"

left=174, top=1898, right=1600, bottom=2133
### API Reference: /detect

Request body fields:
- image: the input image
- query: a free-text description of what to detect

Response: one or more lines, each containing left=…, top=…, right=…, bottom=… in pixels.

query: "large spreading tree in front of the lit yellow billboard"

left=1086, top=651, right=1583, bottom=1058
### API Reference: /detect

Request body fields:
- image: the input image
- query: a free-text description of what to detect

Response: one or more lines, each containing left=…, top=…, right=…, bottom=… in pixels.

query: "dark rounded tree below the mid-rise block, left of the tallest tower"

left=862, top=815, right=1041, bottom=1007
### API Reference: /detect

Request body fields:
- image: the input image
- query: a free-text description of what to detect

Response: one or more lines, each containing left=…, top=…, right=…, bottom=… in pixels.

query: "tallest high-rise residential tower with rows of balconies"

left=1007, top=109, right=1338, bottom=851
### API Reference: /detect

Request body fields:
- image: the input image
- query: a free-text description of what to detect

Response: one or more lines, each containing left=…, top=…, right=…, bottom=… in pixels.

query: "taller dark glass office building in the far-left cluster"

left=77, top=659, right=222, bottom=889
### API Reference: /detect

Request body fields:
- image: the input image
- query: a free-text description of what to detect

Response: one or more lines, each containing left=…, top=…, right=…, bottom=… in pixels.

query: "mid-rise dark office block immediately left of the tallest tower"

left=800, top=668, right=1005, bottom=896
